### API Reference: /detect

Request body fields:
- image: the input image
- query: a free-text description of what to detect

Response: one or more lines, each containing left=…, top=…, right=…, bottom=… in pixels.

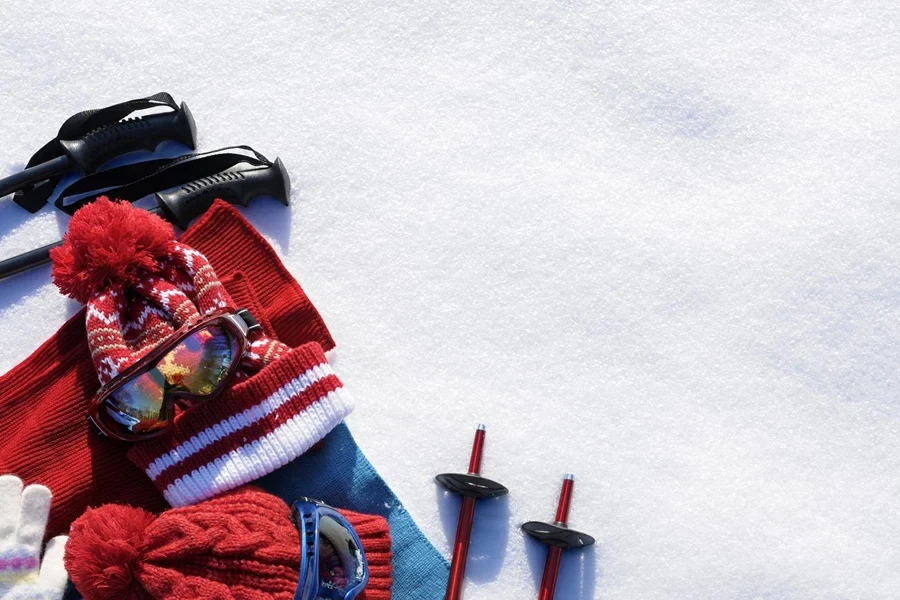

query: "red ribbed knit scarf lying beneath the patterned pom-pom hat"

left=0, top=201, right=334, bottom=537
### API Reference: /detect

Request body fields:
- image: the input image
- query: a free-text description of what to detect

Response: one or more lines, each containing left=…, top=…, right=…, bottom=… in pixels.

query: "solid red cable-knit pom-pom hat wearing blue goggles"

left=65, top=488, right=391, bottom=600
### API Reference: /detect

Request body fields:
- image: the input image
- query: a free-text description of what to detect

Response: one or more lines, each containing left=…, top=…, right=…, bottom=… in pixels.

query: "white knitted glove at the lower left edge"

left=0, top=475, right=68, bottom=600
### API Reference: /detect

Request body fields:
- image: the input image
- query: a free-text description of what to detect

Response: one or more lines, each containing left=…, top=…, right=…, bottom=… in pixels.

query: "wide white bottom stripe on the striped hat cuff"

left=156, top=388, right=353, bottom=508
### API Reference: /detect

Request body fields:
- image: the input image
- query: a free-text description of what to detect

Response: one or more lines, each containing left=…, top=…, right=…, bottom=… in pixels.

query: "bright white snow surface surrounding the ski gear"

left=0, top=0, right=900, bottom=600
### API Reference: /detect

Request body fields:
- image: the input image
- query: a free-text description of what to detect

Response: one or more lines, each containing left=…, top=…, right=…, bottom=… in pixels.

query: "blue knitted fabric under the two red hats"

left=253, top=423, right=450, bottom=600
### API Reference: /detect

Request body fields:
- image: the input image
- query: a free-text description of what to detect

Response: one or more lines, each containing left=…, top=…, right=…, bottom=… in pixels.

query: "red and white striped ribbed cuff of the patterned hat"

left=128, top=342, right=353, bottom=507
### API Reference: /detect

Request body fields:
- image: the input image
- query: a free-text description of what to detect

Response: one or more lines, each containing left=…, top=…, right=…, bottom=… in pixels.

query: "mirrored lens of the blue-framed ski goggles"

left=316, top=515, right=366, bottom=600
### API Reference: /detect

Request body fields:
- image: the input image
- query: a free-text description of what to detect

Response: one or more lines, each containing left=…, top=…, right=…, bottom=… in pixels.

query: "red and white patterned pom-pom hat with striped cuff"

left=51, top=198, right=352, bottom=507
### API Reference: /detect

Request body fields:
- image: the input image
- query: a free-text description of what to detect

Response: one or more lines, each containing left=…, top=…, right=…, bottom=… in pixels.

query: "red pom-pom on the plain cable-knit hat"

left=64, top=504, right=156, bottom=600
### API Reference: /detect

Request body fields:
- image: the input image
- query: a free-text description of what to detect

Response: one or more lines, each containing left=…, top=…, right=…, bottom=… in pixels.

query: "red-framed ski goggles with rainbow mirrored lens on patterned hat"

left=88, top=310, right=259, bottom=442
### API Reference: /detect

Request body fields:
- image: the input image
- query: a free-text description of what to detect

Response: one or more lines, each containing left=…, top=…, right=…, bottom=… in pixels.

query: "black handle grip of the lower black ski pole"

left=156, top=158, right=291, bottom=229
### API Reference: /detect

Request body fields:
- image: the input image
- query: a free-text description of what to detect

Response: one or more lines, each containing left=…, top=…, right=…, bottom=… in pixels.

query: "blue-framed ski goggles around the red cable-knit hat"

left=291, top=498, right=369, bottom=600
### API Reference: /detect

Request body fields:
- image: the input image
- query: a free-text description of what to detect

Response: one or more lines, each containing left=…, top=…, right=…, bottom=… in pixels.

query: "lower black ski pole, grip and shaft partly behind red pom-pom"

left=0, top=158, right=291, bottom=280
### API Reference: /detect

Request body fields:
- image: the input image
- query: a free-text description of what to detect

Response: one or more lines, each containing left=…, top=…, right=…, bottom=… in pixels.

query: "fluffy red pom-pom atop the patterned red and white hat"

left=50, top=197, right=175, bottom=304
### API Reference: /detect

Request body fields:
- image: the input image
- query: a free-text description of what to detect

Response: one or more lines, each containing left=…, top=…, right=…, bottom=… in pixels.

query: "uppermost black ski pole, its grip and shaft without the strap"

left=0, top=102, right=197, bottom=197
